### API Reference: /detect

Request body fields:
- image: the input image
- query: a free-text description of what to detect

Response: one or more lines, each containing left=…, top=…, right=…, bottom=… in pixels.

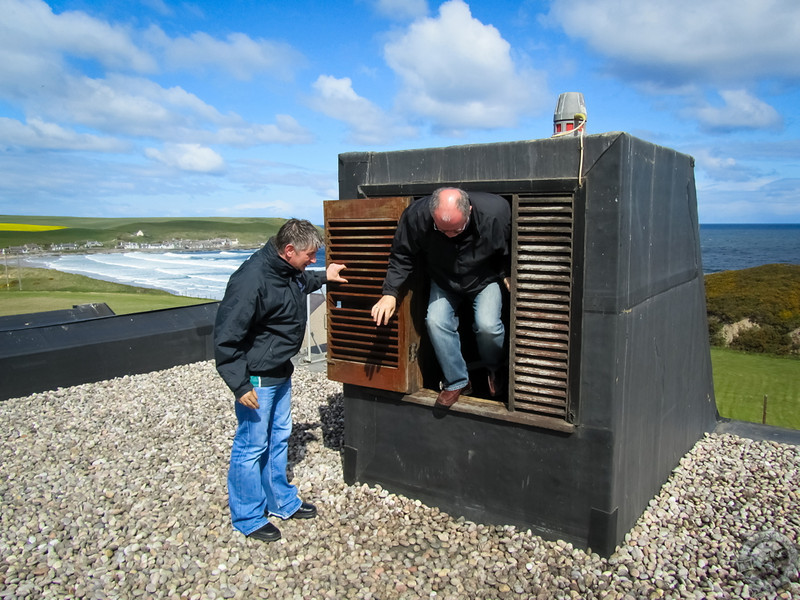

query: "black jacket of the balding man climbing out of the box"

left=383, top=192, right=511, bottom=297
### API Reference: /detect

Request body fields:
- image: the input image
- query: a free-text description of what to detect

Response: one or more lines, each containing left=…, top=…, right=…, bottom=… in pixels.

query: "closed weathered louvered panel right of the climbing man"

left=509, top=194, right=574, bottom=428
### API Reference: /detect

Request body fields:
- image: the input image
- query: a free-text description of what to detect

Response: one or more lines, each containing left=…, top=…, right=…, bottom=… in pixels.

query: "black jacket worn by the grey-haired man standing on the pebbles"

left=214, top=239, right=327, bottom=398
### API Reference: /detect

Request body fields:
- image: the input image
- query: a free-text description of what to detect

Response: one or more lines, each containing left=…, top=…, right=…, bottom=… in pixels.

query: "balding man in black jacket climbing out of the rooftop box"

left=372, top=188, right=511, bottom=407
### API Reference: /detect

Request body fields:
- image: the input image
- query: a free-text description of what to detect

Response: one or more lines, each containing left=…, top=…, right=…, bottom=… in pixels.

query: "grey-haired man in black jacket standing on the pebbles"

left=214, top=219, right=347, bottom=542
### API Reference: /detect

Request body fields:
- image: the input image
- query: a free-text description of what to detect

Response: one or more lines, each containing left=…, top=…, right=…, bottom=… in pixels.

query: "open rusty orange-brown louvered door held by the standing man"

left=325, top=197, right=422, bottom=394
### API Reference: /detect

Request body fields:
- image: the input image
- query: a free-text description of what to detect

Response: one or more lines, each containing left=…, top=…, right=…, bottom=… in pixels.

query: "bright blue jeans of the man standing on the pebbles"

left=228, top=380, right=302, bottom=535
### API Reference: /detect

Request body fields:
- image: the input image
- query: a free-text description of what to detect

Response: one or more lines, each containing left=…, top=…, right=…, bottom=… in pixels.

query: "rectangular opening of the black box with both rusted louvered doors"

left=325, top=186, right=580, bottom=432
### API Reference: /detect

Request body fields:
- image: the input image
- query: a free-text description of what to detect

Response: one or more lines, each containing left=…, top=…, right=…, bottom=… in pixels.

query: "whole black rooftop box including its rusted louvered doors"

left=325, top=132, right=716, bottom=555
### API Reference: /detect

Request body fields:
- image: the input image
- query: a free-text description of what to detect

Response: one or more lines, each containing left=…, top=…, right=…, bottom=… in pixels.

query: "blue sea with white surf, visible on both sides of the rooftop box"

left=25, top=224, right=800, bottom=300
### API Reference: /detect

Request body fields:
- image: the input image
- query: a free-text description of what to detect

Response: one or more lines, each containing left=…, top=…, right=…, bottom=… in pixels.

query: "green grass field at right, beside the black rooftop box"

left=711, top=348, right=800, bottom=429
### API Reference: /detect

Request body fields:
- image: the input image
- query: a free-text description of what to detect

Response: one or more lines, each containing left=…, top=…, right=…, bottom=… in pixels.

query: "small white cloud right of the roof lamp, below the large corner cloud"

left=687, top=90, right=783, bottom=132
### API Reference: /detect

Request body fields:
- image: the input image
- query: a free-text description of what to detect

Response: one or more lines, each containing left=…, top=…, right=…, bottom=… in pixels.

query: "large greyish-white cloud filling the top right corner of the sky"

left=548, top=0, right=800, bottom=84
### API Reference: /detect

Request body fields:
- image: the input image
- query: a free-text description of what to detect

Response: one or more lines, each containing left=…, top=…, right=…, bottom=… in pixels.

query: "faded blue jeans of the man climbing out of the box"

left=425, top=282, right=506, bottom=390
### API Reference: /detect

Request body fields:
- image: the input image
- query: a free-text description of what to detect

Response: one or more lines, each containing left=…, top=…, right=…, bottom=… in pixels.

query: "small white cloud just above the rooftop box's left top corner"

left=311, top=75, right=416, bottom=144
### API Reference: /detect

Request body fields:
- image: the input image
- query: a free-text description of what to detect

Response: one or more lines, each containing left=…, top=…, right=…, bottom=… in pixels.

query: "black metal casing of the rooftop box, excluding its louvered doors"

left=339, top=132, right=716, bottom=555
